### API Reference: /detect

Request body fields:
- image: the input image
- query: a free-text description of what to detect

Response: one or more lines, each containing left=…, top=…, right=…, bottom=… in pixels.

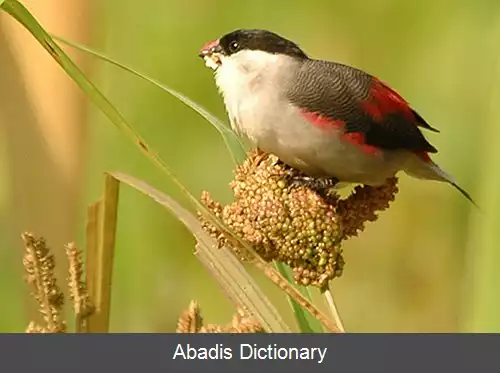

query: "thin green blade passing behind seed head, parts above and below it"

left=52, top=35, right=322, bottom=333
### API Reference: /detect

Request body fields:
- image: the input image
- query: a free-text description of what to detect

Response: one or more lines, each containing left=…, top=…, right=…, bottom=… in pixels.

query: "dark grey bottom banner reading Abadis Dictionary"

left=0, top=334, right=500, bottom=373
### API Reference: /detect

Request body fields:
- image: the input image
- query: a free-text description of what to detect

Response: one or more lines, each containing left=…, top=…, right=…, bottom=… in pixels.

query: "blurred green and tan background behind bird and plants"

left=0, top=0, right=500, bottom=332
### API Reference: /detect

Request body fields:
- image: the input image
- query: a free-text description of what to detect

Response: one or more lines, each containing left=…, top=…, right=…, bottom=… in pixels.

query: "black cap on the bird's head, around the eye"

left=219, top=30, right=307, bottom=58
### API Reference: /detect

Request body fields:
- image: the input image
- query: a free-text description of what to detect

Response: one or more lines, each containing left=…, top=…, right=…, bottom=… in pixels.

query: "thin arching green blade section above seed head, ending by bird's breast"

left=52, top=35, right=246, bottom=164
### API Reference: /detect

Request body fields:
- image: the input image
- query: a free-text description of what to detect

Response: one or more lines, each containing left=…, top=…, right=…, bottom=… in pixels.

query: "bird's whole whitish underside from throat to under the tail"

left=209, top=51, right=405, bottom=185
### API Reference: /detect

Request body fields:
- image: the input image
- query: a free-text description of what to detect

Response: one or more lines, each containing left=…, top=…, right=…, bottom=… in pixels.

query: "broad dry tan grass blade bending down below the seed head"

left=109, top=173, right=290, bottom=333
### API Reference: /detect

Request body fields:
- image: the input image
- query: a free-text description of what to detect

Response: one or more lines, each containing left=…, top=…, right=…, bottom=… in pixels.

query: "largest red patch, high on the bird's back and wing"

left=361, top=78, right=416, bottom=122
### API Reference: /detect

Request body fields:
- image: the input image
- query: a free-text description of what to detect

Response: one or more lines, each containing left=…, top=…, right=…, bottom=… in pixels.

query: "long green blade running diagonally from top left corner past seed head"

left=1, top=0, right=341, bottom=333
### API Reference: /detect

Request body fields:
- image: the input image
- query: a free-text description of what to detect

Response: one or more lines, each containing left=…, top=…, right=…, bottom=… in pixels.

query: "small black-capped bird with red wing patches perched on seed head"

left=199, top=29, right=475, bottom=204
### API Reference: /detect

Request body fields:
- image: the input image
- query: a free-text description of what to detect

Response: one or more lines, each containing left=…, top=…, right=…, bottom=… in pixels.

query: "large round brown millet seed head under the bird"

left=201, top=150, right=397, bottom=288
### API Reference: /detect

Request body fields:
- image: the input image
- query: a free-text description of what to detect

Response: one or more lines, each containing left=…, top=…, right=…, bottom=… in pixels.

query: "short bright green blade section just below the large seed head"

left=274, top=262, right=323, bottom=333
